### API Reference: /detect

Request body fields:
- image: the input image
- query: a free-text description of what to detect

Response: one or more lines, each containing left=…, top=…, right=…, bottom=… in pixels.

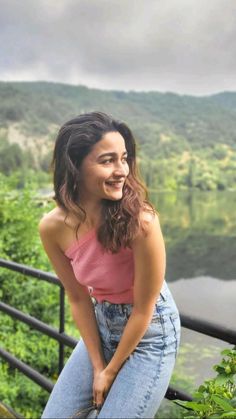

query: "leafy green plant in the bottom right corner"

left=178, top=347, right=236, bottom=419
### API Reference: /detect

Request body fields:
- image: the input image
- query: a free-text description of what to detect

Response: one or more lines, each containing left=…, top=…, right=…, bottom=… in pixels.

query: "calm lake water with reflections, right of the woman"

left=150, top=191, right=236, bottom=390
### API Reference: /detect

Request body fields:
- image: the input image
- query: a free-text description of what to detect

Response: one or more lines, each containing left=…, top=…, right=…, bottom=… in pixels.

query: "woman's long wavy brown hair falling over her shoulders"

left=52, top=112, right=155, bottom=253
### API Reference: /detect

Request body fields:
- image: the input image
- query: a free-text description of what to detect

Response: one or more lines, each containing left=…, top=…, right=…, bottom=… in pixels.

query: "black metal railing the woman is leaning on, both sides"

left=0, top=258, right=236, bottom=412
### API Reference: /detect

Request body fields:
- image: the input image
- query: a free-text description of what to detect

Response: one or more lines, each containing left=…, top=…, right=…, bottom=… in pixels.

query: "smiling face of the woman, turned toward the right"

left=79, top=132, right=129, bottom=203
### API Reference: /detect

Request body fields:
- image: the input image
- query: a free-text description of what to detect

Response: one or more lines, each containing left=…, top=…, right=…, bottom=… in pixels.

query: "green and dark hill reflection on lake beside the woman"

left=150, top=191, right=236, bottom=282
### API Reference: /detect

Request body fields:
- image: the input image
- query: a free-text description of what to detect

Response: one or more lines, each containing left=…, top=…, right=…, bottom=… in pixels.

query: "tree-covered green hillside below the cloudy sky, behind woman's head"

left=0, top=82, right=236, bottom=189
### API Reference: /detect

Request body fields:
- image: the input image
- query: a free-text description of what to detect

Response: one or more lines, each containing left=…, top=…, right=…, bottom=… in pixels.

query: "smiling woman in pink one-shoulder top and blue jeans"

left=39, top=112, right=180, bottom=418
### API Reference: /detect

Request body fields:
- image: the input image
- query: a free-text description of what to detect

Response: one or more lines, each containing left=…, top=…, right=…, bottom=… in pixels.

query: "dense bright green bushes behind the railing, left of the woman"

left=0, top=174, right=78, bottom=418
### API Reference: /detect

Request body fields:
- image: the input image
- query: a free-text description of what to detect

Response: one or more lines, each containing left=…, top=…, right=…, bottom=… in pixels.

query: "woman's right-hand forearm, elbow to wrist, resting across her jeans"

left=106, top=308, right=152, bottom=374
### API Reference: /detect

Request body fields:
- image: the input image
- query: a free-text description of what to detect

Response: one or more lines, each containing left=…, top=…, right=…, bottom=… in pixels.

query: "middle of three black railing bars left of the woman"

left=0, top=302, right=78, bottom=348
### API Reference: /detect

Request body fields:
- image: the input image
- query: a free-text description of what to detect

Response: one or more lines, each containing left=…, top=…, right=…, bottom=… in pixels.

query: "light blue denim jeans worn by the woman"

left=42, top=282, right=180, bottom=419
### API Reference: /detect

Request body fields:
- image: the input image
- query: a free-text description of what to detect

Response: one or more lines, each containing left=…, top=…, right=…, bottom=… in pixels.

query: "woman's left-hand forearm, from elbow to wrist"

left=70, top=296, right=106, bottom=371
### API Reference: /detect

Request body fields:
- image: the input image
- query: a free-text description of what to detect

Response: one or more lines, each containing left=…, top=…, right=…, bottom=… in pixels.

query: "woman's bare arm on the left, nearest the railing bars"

left=39, top=216, right=106, bottom=373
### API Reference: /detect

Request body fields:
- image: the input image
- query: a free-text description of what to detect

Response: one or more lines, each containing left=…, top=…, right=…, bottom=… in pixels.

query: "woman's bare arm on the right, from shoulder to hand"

left=96, top=215, right=166, bottom=404
